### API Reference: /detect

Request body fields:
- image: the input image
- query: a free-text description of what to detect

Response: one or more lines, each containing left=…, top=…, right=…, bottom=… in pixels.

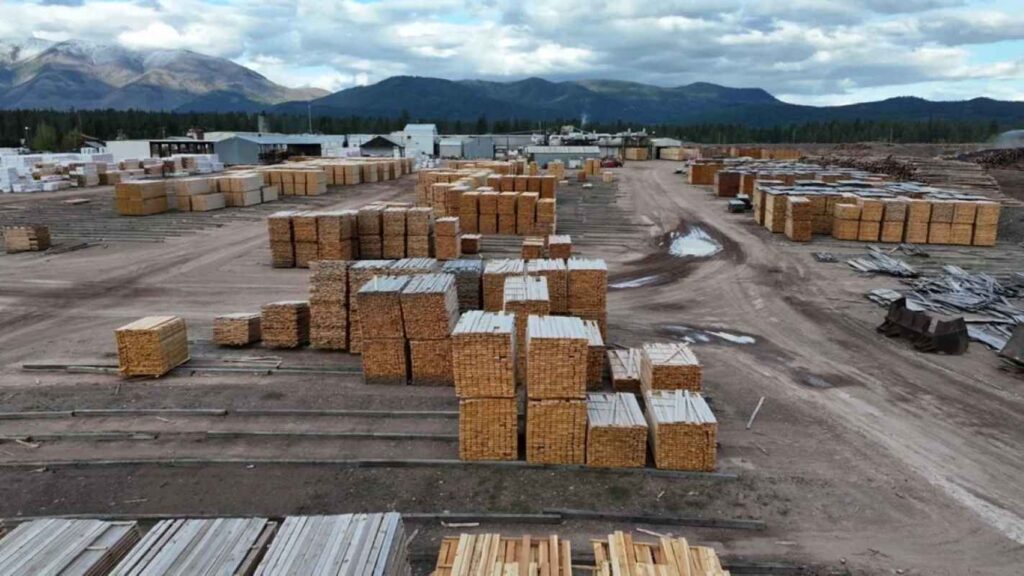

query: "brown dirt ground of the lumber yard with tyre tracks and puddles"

left=0, top=162, right=1024, bottom=576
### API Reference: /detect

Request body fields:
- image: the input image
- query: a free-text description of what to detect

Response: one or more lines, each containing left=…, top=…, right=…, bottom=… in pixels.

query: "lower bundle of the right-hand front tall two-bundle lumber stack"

left=526, top=399, right=587, bottom=464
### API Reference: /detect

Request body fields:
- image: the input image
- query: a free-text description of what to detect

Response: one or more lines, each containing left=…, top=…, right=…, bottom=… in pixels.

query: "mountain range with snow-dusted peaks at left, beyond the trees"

left=0, top=40, right=1024, bottom=126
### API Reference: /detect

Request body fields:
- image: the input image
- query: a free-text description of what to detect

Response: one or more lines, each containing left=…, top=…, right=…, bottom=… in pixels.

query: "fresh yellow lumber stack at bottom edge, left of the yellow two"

left=431, top=534, right=573, bottom=576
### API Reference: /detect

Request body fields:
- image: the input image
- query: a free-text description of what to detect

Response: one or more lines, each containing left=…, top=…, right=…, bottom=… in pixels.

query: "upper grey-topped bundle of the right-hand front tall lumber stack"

left=526, top=316, right=589, bottom=400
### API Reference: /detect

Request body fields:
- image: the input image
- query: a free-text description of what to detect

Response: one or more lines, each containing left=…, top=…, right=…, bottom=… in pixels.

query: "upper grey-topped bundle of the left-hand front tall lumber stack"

left=452, top=311, right=515, bottom=399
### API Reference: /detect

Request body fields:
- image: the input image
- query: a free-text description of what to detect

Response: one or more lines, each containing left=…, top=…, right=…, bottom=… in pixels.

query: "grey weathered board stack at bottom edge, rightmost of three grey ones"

left=255, top=512, right=412, bottom=576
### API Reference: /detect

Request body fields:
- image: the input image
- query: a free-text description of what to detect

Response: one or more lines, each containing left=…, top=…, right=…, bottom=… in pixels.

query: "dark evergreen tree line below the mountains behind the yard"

left=0, top=110, right=1018, bottom=151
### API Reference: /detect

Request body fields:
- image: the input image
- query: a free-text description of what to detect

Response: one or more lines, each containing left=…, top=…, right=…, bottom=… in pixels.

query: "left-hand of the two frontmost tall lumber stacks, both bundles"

left=452, top=311, right=519, bottom=460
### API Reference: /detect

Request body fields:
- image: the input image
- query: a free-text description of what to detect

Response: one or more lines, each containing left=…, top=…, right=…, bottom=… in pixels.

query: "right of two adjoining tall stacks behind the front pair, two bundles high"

left=401, top=274, right=459, bottom=385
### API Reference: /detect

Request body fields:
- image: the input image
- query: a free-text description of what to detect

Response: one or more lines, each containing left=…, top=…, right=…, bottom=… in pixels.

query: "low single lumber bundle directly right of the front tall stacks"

left=587, top=393, right=647, bottom=468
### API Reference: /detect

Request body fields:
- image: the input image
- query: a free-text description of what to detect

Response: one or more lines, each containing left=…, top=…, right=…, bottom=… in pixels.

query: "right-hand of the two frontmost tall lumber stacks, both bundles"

left=526, top=316, right=589, bottom=464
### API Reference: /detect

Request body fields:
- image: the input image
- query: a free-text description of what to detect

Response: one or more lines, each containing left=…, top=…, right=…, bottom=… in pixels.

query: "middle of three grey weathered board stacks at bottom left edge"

left=111, top=518, right=278, bottom=576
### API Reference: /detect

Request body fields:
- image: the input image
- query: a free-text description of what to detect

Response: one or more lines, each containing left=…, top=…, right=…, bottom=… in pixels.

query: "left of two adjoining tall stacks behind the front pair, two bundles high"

left=355, top=276, right=409, bottom=384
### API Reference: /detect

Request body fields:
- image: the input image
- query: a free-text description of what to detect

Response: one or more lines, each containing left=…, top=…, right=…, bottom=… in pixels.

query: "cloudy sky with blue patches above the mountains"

left=0, top=0, right=1024, bottom=105
